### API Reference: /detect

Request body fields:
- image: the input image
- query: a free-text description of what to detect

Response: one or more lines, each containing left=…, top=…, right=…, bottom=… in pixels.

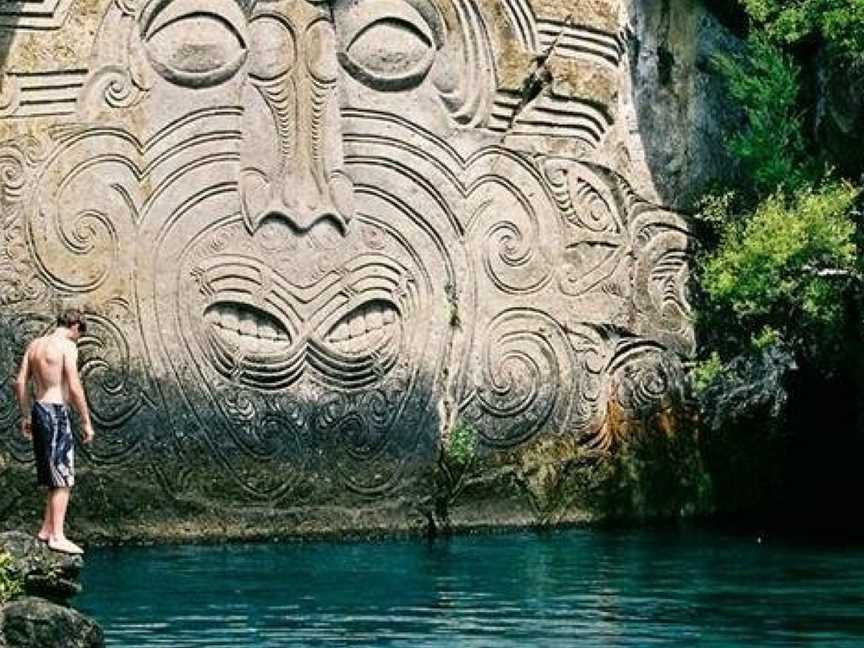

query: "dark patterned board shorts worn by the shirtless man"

left=31, top=401, right=75, bottom=488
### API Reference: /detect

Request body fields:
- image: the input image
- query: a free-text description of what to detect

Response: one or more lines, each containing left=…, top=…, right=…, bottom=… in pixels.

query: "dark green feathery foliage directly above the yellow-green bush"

left=714, top=33, right=815, bottom=196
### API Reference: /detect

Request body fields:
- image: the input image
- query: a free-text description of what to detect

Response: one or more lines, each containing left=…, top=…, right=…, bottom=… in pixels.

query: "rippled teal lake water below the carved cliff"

left=73, top=530, right=864, bottom=648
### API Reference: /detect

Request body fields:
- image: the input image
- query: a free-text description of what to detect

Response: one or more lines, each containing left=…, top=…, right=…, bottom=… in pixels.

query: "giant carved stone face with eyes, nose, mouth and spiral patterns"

left=3, top=0, right=692, bottom=498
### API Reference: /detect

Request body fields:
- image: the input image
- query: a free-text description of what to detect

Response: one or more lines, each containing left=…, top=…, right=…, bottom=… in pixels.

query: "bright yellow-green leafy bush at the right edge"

left=700, top=183, right=859, bottom=360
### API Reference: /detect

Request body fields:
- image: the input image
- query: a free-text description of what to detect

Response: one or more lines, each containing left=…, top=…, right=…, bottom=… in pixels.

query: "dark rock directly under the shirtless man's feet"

left=0, top=531, right=83, bottom=602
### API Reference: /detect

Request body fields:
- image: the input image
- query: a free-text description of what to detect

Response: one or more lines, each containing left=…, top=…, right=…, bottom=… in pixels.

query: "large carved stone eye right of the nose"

left=336, top=1, right=438, bottom=90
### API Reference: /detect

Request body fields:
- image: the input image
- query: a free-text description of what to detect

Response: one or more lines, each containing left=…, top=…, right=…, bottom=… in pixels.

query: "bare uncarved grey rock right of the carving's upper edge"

left=628, top=0, right=744, bottom=208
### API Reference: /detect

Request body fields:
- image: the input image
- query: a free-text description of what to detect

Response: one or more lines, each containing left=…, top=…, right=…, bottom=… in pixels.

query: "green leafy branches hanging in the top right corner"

left=741, top=0, right=864, bottom=59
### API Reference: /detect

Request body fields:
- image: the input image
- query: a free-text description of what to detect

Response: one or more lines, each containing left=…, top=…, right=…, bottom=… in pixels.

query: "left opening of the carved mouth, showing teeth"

left=204, top=302, right=291, bottom=355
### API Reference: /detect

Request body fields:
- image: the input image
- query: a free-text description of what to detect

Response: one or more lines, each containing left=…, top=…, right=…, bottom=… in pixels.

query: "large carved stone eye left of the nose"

left=142, top=0, right=246, bottom=87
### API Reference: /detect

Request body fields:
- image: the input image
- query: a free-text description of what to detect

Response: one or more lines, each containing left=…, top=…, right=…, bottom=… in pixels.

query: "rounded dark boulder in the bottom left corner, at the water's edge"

left=0, top=596, right=105, bottom=648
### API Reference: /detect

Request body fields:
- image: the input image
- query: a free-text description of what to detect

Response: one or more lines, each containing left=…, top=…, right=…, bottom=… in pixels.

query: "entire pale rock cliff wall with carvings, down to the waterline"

left=0, top=0, right=725, bottom=538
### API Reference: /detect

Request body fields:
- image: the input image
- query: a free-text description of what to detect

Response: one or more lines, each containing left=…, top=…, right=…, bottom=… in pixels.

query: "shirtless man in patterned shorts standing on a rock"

left=15, top=310, right=94, bottom=554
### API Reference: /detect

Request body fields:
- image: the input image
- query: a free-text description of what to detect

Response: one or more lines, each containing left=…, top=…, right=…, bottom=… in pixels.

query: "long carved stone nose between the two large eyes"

left=240, top=12, right=354, bottom=233
